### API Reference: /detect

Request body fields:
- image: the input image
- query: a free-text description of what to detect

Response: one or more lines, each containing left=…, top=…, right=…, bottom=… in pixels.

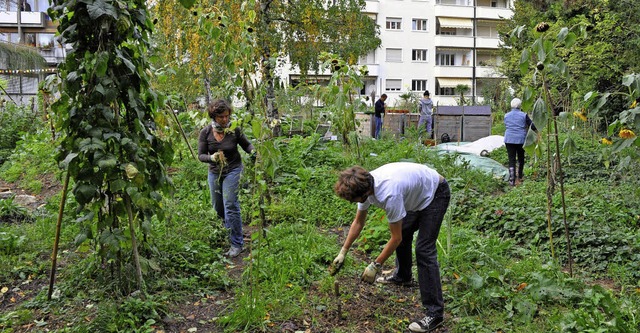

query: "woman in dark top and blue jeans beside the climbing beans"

left=198, top=99, right=255, bottom=257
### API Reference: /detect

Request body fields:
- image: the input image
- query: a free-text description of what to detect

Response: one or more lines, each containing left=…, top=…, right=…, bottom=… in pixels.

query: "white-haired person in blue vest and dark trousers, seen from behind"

left=504, top=98, right=536, bottom=186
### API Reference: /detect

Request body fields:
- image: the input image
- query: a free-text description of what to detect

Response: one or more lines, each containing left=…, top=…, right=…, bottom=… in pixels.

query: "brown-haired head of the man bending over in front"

left=333, top=166, right=373, bottom=202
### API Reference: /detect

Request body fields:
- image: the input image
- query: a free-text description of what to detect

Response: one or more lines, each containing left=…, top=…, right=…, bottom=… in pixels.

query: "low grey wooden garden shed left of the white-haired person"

left=433, top=105, right=491, bottom=142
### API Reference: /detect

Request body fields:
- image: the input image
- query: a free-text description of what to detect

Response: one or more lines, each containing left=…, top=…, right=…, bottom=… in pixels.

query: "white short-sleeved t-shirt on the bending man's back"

left=358, top=162, right=440, bottom=223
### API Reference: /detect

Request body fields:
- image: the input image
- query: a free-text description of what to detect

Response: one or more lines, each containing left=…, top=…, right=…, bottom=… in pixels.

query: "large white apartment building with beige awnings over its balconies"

left=281, top=0, right=514, bottom=106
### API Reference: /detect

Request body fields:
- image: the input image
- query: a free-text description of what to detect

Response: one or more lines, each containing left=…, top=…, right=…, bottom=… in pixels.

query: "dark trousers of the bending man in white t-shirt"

left=395, top=180, right=451, bottom=317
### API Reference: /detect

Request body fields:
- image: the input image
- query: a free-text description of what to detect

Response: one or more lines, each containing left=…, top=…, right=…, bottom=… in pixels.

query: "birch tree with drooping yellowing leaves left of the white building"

left=154, top=0, right=380, bottom=131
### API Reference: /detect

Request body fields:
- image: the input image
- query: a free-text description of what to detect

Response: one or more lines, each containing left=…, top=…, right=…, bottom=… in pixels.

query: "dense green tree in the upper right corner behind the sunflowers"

left=499, top=0, right=640, bottom=129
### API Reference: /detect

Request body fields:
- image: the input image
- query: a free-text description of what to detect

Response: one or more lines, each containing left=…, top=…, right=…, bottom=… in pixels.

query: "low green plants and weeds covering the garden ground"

left=0, top=109, right=640, bottom=332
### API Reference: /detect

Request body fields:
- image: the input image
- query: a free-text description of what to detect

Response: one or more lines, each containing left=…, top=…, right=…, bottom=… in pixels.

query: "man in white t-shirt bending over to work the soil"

left=333, top=162, right=451, bottom=332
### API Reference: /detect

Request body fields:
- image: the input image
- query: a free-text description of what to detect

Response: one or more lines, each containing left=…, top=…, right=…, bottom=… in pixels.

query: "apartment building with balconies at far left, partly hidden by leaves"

left=0, top=0, right=59, bottom=104
